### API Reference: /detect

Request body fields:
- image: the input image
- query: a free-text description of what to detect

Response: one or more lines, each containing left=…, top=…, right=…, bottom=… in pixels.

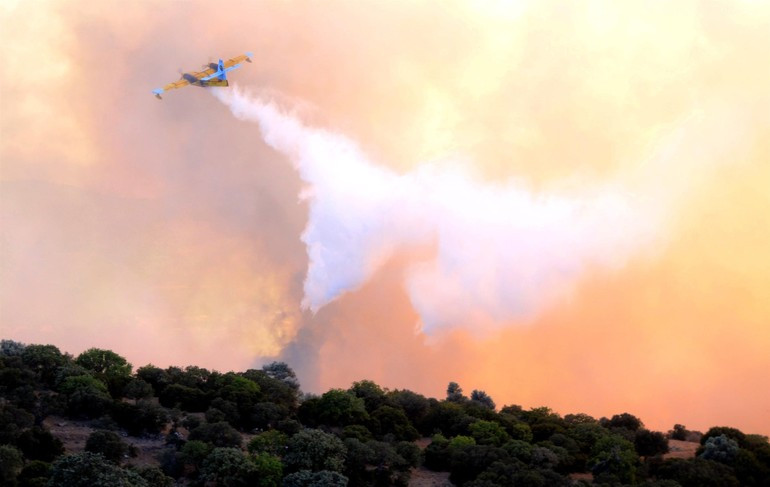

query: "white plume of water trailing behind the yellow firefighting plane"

left=212, top=88, right=657, bottom=332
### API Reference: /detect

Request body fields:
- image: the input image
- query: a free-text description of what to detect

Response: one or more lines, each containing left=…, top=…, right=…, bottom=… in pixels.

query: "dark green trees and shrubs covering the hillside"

left=0, top=340, right=770, bottom=487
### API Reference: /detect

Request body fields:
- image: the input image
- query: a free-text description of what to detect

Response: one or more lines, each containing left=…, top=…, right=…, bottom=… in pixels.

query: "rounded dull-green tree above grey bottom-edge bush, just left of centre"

left=283, top=429, right=346, bottom=472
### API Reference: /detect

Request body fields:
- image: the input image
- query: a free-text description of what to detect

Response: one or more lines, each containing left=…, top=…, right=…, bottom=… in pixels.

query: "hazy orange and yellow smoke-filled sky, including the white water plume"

left=0, top=1, right=770, bottom=434
